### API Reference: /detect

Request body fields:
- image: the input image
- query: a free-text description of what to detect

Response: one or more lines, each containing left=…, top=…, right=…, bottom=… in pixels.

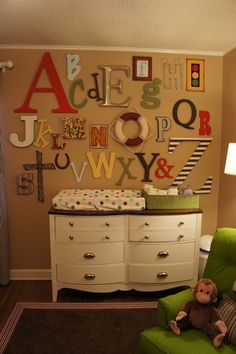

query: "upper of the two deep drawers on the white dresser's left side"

left=56, top=242, right=124, bottom=265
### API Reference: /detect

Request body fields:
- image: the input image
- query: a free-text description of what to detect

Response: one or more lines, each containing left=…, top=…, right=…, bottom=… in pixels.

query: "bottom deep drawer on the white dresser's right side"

left=128, top=262, right=193, bottom=284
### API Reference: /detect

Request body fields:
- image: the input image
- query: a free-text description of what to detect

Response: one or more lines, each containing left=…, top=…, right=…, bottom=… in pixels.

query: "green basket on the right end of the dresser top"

left=143, top=192, right=199, bottom=209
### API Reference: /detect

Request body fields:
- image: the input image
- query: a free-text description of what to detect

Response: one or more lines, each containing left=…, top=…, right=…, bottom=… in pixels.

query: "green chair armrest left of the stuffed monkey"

left=157, top=288, right=193, bottom=329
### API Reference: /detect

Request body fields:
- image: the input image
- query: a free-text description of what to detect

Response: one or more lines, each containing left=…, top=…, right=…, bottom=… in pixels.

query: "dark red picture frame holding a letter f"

left=133, top=56, right=152, bottom=81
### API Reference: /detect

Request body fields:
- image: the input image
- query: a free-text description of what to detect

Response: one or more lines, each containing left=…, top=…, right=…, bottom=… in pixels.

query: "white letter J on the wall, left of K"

left=10, top=116, right=37, bottom=147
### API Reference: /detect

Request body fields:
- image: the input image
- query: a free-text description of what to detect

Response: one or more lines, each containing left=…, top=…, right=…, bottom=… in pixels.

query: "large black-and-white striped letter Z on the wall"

left=168, top=138, right=212, bottom=194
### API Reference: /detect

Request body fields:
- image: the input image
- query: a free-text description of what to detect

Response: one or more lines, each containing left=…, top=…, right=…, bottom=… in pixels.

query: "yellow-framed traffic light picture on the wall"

left=186, top=58, right=205, bottom=92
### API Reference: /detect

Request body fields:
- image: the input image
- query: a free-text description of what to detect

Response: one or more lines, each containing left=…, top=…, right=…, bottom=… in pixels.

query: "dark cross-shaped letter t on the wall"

left=23, top=150, right=56, bottom=202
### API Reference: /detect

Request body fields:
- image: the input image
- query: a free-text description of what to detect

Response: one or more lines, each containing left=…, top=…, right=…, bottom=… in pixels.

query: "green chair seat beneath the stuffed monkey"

left=139, top=327, right=235, bottom=354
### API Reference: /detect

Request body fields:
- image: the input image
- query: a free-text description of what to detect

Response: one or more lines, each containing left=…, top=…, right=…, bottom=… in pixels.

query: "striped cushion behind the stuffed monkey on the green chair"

left=219, top=294, right=236, bottom=350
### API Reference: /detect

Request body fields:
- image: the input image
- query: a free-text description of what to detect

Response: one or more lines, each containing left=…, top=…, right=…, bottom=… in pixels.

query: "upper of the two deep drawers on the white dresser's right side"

left=129, top=242, right=195, bottom=264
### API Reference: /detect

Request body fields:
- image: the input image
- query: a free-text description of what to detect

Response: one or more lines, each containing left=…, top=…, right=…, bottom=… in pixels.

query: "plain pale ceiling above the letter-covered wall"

left=0, top=0, right=236, bottom=54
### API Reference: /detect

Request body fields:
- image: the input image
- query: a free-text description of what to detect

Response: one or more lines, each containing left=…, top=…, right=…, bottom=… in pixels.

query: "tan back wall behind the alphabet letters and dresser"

left=0, top=49, right=223, bottom=269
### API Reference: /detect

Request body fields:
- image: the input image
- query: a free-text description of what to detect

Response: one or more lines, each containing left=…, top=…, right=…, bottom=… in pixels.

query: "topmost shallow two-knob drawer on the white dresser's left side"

left=56, top=215, right=124, bottom=230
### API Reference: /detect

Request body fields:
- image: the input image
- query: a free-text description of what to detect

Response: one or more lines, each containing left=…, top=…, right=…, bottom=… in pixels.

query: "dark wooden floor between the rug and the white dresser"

left=0, top=280, right=184, bottom=331
